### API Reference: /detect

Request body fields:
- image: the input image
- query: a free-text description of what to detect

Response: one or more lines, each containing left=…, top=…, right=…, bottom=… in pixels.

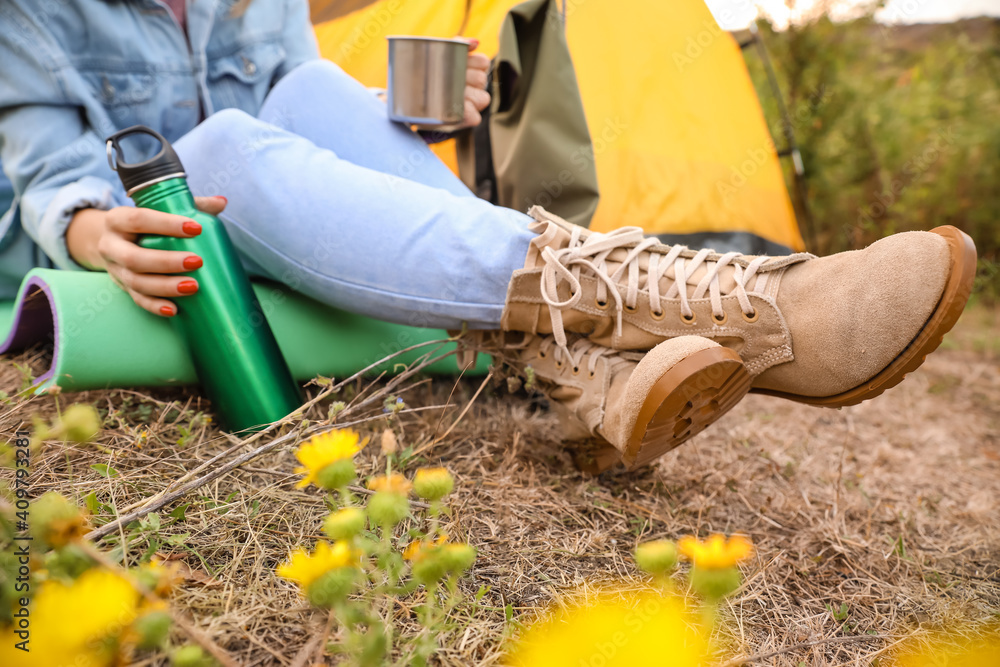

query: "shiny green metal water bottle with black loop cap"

left=107, top=125, right=301, bottom=431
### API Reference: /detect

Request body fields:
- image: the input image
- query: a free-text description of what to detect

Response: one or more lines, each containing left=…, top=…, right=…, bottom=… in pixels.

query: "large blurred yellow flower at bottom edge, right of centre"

left=512, top=593, right=711, bottom=667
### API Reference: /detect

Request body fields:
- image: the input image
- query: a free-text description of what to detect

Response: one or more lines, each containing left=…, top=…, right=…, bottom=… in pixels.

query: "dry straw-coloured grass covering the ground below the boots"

left=0, top=309, right=1000, bottom=666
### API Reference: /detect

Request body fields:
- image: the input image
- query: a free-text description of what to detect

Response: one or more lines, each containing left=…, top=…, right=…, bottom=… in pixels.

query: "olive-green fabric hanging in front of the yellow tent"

left=457, top=0, right=598, bottom=226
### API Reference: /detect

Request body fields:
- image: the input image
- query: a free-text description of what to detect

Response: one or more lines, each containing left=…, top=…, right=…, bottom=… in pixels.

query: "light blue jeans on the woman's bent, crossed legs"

left=176, top=61, right=534, bottom=329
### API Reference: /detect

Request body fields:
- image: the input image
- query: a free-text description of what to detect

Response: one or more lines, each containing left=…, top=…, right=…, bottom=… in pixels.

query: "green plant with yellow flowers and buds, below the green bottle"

left=278, top=430, right=476, bottom=666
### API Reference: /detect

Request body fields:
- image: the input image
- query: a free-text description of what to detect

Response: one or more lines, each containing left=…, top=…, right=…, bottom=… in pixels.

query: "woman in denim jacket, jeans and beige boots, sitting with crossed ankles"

left=0, top=0, right=975, bottom=470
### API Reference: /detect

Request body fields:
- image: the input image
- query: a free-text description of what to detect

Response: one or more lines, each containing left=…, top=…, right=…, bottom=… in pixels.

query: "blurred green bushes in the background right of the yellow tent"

left=746, top=14, right=1000, bottom=302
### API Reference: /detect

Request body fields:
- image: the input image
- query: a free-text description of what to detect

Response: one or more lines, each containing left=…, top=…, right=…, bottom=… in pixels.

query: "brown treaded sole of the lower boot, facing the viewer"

left=621, top=347, right=751, bottom=469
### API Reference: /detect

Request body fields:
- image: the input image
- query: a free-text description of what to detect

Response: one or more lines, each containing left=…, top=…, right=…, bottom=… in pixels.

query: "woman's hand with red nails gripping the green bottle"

left=66, top=197, right=226, bottom=317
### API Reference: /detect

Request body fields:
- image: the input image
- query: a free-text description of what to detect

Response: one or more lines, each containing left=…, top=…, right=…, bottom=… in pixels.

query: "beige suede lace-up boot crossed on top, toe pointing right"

left=501, top=206, right=976, bottom=407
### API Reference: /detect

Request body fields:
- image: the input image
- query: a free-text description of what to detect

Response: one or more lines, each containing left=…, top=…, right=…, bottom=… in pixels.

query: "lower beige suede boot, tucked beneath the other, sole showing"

left=467, top=332, right=750, bottom=469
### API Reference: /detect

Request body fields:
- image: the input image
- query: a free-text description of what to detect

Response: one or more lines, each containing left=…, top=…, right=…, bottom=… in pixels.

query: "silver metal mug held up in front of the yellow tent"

left=387, top=35, right=469, bottom=129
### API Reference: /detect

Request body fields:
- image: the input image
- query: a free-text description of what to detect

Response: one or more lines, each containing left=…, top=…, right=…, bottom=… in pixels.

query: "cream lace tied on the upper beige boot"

left=539, top=227, right=770, bottom=348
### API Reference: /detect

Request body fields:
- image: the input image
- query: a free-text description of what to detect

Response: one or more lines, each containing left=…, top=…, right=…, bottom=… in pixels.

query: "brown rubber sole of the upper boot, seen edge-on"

left=751, top=225, right=976, bottom=408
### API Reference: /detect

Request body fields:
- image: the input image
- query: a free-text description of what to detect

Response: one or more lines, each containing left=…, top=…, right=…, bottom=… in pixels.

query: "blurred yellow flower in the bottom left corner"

left=0, top=568, right=139, bottom=667
